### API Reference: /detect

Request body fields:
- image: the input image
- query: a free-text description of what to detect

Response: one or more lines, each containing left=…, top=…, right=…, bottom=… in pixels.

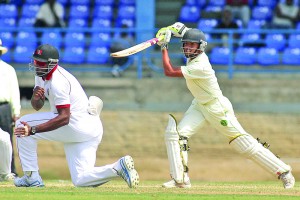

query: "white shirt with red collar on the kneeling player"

left=35, top=66, right=102, bottom=136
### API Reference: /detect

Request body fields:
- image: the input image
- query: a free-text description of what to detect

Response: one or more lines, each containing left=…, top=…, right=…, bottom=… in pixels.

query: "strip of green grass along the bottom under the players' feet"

left=0, top=180, right=300, bottom=200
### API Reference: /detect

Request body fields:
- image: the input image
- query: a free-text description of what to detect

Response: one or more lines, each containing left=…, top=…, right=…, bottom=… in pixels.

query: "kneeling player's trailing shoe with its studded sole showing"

left=117, top=156, right=139, bottom=188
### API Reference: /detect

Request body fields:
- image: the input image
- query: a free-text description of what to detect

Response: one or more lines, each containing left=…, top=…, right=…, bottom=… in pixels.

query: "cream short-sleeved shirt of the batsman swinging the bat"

left=181, top=52, right=223, bottom=104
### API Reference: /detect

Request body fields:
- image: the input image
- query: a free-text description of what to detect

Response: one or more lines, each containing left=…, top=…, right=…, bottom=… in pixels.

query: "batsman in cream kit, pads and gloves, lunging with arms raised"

left=156, top=22, right=295, bottom=189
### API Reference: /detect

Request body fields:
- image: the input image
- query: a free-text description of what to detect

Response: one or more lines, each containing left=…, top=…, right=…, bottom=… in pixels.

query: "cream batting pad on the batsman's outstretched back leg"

left=231, top=135, right=291, bottom=175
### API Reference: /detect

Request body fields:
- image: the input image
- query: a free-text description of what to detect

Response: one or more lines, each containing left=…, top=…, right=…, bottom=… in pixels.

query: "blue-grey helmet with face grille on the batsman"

left=181, top=28, right=207, bottom=58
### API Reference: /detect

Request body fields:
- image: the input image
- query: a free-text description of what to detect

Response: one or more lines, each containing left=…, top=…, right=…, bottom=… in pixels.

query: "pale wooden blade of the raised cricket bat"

left=110, top=38, right=158, bottom=58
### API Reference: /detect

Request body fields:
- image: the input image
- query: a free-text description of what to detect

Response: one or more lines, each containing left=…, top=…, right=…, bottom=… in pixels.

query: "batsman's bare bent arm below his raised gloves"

left=161, top=49, right=183, bottom=77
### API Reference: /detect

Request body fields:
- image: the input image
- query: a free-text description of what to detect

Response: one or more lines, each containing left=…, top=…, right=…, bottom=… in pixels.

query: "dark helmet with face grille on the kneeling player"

left=29, top=44, right=59, bottom=77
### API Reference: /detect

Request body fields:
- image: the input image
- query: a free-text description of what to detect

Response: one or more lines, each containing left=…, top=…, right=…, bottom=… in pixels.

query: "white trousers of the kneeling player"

left=16, top=112, right=118, bottom=186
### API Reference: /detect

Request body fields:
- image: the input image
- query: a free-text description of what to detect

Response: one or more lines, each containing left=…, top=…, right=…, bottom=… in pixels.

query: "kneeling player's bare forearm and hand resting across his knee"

left=14, top=108, right=71, bottom=136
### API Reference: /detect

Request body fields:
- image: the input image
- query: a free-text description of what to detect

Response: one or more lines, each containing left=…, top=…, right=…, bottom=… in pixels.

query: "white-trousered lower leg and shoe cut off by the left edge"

left=0, top=128, right=15, bottom=182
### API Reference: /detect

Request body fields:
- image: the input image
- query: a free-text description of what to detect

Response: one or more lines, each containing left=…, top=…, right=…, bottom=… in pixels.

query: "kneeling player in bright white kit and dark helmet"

left=14, top=44, right=139, bottom=188
